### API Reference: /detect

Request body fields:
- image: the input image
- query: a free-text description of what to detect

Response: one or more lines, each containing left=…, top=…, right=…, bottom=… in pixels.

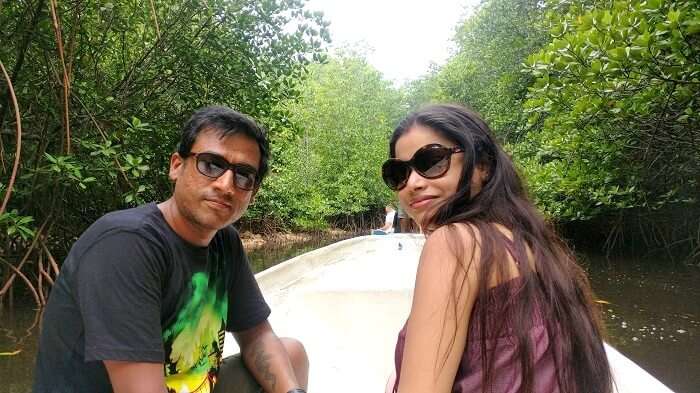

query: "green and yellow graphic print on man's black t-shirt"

left=163, top=272, right=228, bottom=393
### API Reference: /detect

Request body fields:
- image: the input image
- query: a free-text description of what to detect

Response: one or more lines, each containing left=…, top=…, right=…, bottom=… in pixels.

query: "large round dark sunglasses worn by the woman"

left=382, top=143, right=464, bottom=191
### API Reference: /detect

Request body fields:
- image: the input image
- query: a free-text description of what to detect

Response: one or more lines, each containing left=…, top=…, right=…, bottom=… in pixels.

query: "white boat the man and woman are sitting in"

left=224, top=234, right=672, bottom=393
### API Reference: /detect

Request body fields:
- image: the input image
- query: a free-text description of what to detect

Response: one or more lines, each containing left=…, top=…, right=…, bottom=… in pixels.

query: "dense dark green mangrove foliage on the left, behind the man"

left=0, top=0, right=329, bottom=257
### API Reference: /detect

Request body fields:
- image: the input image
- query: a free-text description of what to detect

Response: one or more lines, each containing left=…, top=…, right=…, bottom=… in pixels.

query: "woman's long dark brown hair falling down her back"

left=389, top=105, right=613, bottom=393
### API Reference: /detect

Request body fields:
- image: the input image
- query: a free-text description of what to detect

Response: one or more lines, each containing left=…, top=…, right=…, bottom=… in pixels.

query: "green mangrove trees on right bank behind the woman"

left=396, top=0, right=700, bottom=256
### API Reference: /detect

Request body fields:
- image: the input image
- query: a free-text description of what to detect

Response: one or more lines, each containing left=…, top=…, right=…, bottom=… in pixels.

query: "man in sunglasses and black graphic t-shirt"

left=34, top=107, right=308, bottom=393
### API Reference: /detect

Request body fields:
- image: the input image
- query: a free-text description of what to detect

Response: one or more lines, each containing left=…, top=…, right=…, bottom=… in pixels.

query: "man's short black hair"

left=177, top=106, right=270, bottom=185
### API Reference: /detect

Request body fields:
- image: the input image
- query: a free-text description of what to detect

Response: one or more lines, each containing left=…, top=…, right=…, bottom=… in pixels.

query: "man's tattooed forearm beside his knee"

left=242, top=332, right=300, bottom=393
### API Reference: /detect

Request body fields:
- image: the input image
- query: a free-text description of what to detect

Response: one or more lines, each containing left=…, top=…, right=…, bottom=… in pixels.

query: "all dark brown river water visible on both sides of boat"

left=0, top=238, right=700, bottom=393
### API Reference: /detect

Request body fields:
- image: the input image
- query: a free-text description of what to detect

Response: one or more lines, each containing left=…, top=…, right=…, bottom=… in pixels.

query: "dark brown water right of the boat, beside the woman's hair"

left=586, top=256, right=700, bottom=393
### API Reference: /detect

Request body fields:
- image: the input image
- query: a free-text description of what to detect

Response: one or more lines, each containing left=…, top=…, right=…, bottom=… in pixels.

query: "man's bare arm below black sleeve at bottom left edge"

left=104, top=360, right=167, bottom=393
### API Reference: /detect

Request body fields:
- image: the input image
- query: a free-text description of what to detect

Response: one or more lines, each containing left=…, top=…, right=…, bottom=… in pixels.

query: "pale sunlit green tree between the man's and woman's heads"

left=251, top=54, right=401, bottom=229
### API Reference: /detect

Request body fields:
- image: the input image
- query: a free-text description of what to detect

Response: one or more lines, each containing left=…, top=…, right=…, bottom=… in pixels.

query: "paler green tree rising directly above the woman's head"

left=427, top=0, right=546, bottom=140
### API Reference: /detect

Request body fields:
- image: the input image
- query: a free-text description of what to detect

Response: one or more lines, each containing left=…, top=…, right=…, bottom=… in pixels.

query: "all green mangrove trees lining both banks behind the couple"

left=0, top=0, right=700, bottom=303
